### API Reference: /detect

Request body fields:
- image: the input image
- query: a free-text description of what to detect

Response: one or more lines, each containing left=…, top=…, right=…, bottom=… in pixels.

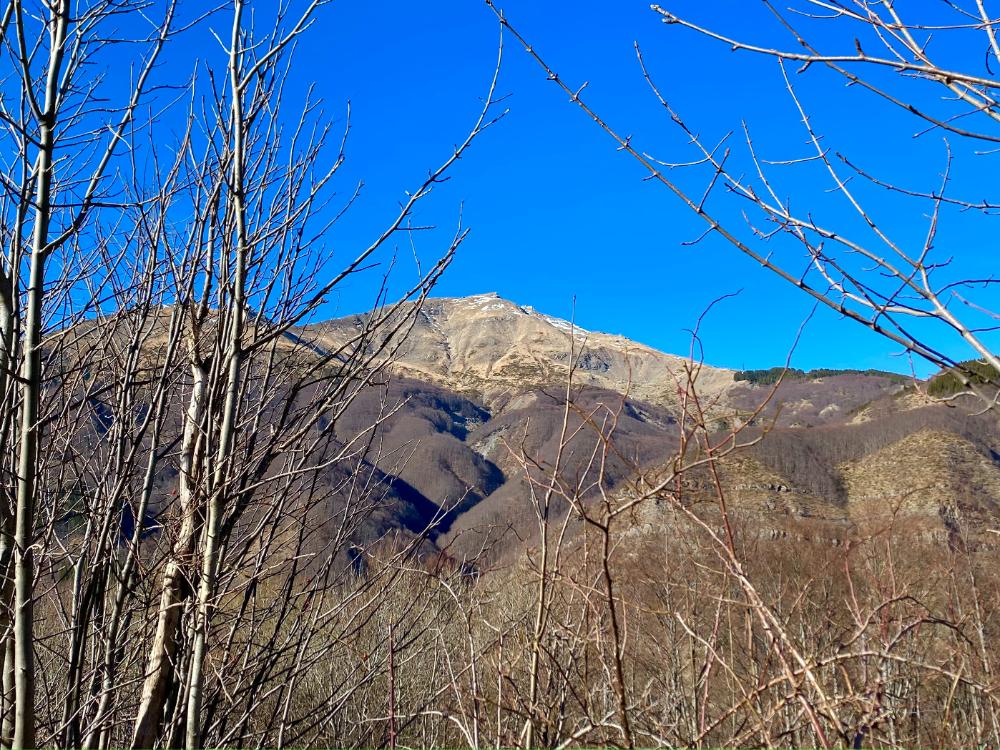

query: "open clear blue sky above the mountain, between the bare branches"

left=164, top=0, right=1000, bottom=373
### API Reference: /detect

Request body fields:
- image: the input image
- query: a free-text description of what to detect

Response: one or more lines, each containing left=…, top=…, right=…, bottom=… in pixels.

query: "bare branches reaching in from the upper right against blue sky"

left=487, top=0, right=1000, bottom=407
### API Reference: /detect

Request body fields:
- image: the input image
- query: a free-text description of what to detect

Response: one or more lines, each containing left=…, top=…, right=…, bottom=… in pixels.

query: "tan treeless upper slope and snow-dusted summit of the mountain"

left=304, top=293, right=920, bottom=427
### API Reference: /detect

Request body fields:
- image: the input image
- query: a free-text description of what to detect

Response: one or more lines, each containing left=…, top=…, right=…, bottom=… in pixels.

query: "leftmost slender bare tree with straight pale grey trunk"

left=2, top=2, right=179, bottom=747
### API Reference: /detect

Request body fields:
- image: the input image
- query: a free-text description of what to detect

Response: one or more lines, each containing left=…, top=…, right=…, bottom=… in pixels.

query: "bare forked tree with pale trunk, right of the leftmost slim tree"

left=132, top=1, right=508, bottom=747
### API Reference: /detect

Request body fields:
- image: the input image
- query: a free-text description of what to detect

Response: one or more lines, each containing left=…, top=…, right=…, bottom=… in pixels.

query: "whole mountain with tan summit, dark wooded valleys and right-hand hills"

left=74, top=294, right=1000, bottom=565
